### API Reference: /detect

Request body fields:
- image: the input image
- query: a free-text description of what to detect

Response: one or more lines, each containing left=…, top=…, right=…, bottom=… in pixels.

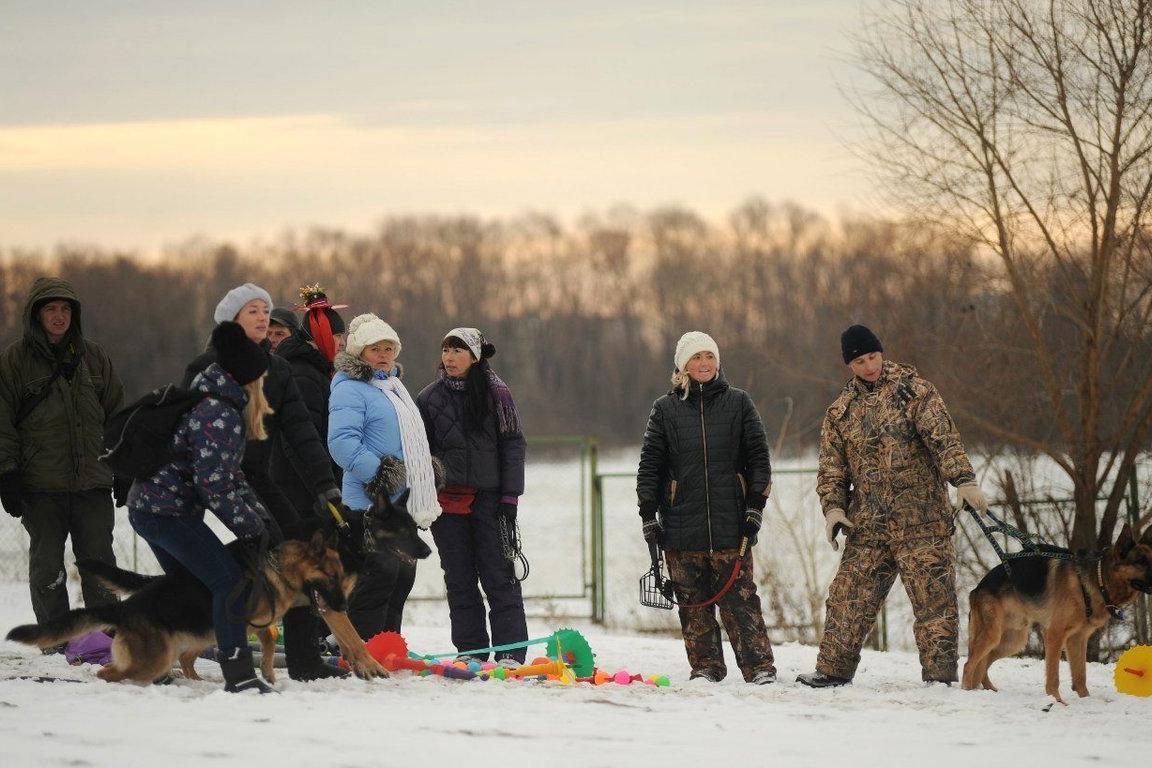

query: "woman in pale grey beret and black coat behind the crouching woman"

left=183, top=283, right=347, bottom=680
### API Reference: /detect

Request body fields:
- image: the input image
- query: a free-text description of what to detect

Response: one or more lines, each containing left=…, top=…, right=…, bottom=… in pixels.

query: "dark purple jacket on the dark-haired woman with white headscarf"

left=416, top=380, right=526, bottom=496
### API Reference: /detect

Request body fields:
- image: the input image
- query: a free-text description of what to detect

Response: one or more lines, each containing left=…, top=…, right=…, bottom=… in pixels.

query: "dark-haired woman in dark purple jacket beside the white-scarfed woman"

left=416, top=328, right=528, bottom=666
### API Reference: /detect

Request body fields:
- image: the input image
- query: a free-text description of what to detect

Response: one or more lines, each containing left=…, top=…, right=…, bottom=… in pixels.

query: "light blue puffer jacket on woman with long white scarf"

left=328, top=352, right=404, bottom=509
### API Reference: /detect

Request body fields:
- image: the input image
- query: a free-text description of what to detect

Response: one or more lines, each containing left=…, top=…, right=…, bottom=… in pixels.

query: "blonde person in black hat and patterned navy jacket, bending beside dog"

left=128, top=322, right=273, bottom=693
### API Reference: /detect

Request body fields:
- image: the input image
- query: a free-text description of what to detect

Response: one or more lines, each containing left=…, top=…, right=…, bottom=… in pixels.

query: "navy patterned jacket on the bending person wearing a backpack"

left=128, top=363, right=267, bottom=539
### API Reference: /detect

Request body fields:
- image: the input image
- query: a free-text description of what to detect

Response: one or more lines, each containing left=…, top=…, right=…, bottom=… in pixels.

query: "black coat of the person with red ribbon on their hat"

left=272, top=334, right=343, bottom=512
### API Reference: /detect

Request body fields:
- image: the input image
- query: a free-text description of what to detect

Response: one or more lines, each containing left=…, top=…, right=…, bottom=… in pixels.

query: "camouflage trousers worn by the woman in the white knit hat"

left=665, top=549, right=775, bottom=680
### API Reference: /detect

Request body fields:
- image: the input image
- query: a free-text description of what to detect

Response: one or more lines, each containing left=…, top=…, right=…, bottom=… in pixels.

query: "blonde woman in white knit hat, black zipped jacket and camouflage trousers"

left=636, top=330, right=776, bottom=685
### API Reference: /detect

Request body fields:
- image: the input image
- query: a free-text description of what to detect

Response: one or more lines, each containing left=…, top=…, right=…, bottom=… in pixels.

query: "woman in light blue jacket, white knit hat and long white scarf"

left=328, top=314, right=440, bottom=640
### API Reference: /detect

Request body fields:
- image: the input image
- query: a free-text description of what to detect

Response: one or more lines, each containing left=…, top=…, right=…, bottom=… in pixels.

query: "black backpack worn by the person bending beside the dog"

left=100, top=385, right=211, bottom=480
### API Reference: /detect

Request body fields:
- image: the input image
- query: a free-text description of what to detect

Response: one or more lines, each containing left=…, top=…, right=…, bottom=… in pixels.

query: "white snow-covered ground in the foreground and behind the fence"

left=0, top=454, right=1152, bottom=768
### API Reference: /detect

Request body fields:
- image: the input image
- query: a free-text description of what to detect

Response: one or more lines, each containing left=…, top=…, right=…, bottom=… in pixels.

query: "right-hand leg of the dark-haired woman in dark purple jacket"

left=471, top=492, right=528, bottom=663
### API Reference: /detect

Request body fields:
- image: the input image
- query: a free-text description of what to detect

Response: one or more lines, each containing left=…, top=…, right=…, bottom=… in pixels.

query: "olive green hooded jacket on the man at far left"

left=0, top=277, right=123, bottom=492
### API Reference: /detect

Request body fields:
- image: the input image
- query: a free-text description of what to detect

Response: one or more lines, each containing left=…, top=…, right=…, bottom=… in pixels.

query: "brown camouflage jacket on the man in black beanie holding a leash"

left=816, top=360, right=976, bottom=543
